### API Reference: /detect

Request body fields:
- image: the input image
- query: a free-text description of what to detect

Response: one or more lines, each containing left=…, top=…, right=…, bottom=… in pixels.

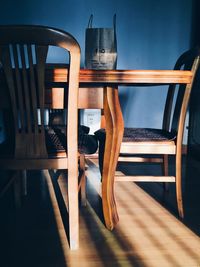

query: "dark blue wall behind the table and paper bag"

left=0, top=0, right=193, bottom=126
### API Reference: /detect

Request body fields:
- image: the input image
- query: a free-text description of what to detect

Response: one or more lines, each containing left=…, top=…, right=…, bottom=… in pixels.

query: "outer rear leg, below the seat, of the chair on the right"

left=176, top=151, right=184, bottom=218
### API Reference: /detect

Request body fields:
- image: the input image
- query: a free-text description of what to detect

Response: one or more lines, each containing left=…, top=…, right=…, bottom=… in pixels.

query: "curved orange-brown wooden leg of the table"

left=102, top=87, right=124, bottom=230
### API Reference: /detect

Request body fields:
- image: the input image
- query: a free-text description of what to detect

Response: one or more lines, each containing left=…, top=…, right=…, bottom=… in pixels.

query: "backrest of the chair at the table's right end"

left=163, top=48, right=200, bottom=136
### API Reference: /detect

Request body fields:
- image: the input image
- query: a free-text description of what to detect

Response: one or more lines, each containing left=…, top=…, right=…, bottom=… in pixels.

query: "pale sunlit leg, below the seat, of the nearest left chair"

left=68, top=162, right=79, bottom=250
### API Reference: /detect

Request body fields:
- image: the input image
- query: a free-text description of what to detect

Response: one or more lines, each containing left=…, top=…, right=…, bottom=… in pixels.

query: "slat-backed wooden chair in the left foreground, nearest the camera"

left=0, top=25, right=80, bottom=249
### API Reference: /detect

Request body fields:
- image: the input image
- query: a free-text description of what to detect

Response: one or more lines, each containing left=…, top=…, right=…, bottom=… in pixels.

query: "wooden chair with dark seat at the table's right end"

left=97, top=49, right=200, bottom=218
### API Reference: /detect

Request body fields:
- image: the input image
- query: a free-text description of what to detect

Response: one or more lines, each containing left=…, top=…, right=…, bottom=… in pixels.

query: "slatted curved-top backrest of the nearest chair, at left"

left=0, top=25, right=80, bottom=158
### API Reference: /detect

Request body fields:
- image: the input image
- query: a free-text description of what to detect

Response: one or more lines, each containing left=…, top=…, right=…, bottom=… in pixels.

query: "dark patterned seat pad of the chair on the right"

left=123, top=128, right=176, bottom=142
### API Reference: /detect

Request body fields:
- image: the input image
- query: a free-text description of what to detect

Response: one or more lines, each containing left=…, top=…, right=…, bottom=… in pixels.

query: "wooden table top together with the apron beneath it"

left=0, top=68, right=192, bottom=109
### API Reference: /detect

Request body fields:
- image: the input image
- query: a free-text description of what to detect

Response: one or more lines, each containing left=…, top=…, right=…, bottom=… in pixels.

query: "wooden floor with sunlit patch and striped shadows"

left=0, top=156, right=200, bottom=267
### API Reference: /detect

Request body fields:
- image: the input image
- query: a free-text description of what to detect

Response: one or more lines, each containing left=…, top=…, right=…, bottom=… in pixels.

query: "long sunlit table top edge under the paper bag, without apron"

left=46, top=68, right=192, bottom=86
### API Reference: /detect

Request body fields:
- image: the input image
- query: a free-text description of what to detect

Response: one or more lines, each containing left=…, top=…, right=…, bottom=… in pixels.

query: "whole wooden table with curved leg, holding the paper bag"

left=0, top=65, right=194, bottom=230
